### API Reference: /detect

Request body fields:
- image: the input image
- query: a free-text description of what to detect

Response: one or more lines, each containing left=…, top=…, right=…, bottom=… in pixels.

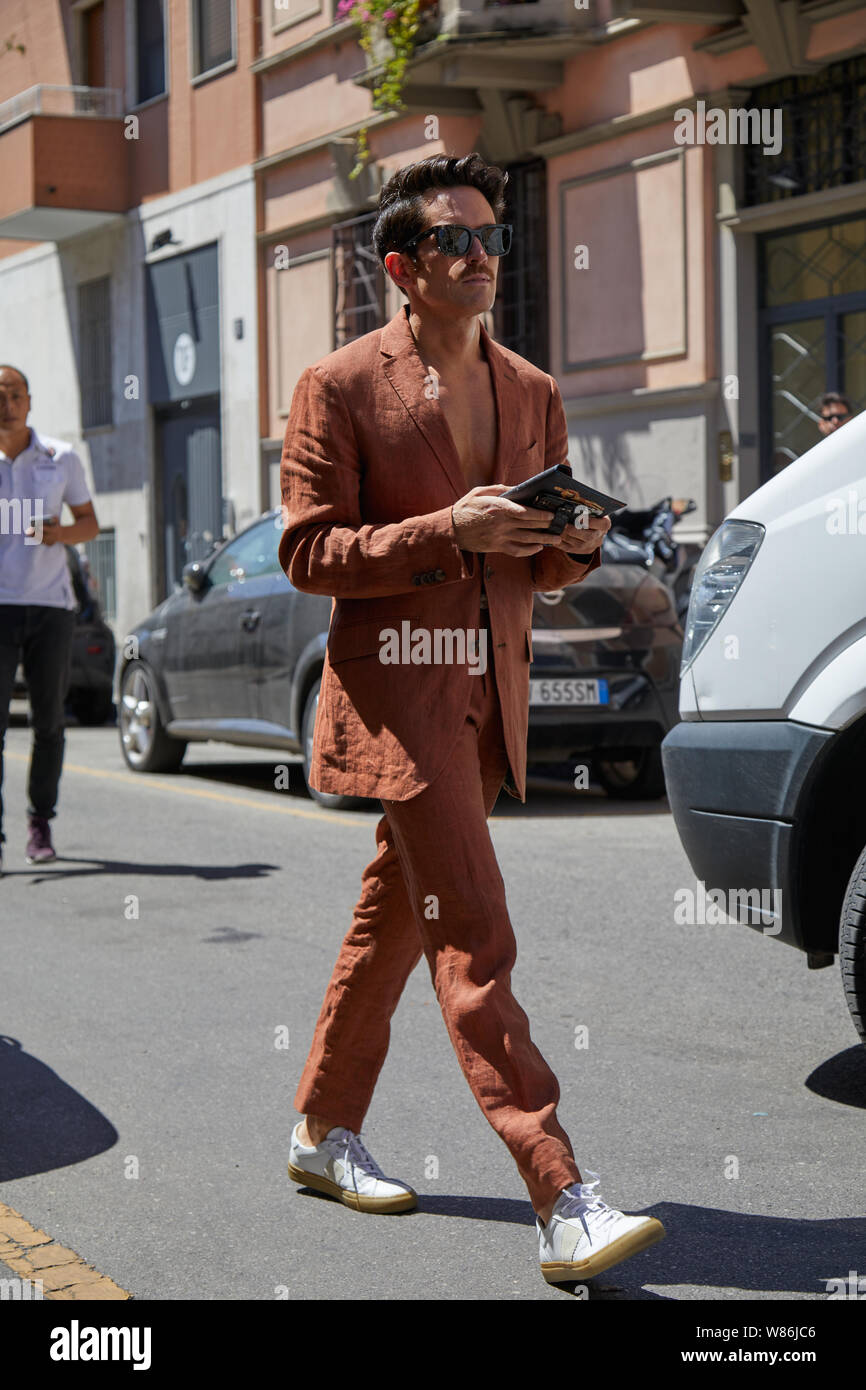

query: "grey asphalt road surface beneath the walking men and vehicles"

left=0, top=706, right=866, bottom=1302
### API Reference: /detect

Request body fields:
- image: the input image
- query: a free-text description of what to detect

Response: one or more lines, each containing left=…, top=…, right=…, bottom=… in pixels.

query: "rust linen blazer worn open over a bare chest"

left=279, top=306, right=601, bottom=801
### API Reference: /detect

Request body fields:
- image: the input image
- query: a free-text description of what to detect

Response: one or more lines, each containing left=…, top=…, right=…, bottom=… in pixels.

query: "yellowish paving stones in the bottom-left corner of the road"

left=0, top=1202, right=132, bottom=1300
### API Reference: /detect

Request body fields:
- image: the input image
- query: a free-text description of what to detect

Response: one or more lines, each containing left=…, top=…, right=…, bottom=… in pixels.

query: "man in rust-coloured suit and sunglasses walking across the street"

left=279, top=154, right=663, bottom=1282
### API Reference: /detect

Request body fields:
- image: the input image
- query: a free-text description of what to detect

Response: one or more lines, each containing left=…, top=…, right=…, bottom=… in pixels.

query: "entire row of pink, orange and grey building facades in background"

left=0, top=0, right=866, bottom=635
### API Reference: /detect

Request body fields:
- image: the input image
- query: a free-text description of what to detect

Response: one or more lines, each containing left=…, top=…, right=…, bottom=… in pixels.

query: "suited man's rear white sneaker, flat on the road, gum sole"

left=289, top=1122, right=417, bottom=1212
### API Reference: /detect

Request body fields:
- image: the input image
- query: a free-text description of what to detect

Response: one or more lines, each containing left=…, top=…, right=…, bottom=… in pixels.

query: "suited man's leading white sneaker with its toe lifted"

left=535, top=1173, right=666, bottom=1284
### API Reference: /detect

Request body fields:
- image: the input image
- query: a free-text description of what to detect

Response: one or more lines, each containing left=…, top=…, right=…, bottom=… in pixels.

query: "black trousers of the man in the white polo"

left=0, top=603, right=75, bottom=844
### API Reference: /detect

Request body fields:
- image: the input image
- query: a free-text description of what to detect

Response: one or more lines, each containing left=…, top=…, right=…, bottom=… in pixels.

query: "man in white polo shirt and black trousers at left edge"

left=0, top=366, right=99, bottom=873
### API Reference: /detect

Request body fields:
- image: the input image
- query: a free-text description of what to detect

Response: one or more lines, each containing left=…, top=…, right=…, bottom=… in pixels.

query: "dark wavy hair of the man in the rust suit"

left=373, top=153, right=509, bottom=293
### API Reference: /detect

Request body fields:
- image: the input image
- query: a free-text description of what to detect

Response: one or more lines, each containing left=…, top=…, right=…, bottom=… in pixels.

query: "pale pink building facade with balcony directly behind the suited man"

left=254, top=0, right=866, bottom=539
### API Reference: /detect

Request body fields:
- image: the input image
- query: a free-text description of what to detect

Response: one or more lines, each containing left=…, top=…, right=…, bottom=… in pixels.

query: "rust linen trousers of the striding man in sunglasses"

left=295, top=612, right=580, bottom=1211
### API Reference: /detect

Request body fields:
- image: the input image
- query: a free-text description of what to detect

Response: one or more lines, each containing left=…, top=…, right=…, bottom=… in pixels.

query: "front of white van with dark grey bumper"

left=662, top=413, right=866, bottom=1043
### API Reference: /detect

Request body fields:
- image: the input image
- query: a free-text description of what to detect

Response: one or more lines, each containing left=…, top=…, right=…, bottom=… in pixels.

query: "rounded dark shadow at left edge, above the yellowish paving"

left=0, top=1034, right=118, bottom=1183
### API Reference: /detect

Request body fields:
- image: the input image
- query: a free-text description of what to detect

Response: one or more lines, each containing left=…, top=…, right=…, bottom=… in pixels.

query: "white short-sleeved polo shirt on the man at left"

left=0, top=427, right=90, bottom=609
